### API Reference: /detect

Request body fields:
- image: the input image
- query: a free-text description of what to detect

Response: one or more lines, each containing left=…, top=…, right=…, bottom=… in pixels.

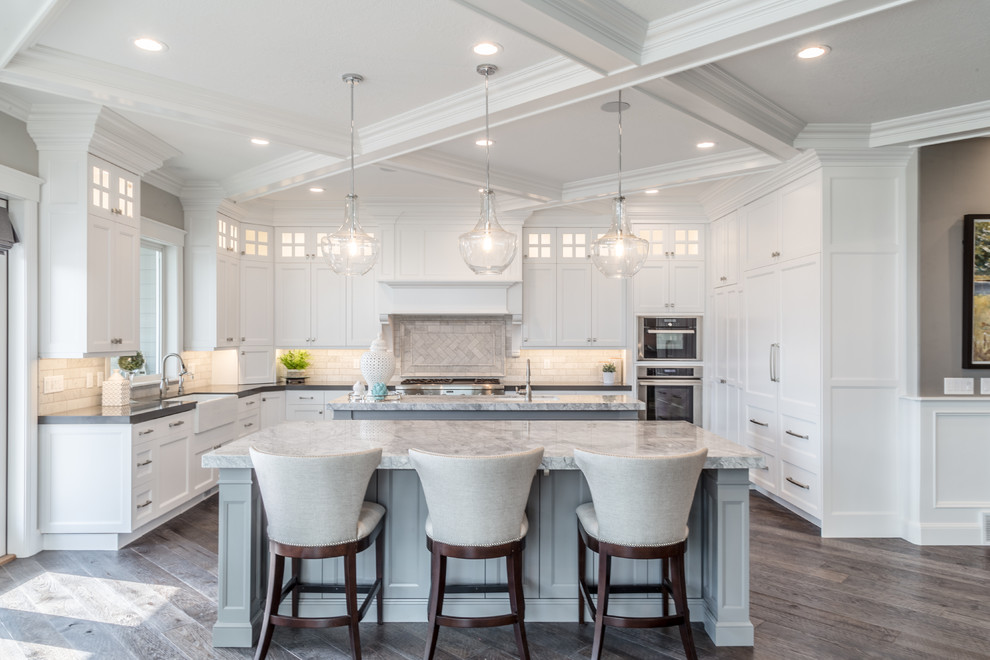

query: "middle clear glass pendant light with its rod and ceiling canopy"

left=459, top=64, right=516, bottom=275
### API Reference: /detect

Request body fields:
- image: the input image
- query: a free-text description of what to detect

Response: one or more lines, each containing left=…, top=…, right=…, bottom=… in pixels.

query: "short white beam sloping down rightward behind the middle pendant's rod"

left=379, top=150, right=561, bottom=202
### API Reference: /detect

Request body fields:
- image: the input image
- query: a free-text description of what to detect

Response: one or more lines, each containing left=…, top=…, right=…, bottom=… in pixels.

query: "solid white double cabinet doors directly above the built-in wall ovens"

left=632, top=259, right=705, bottom=315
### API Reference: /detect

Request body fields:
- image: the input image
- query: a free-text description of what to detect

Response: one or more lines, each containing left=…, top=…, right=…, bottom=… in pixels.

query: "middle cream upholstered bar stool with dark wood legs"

left=409, top=447, right=543, bottom=660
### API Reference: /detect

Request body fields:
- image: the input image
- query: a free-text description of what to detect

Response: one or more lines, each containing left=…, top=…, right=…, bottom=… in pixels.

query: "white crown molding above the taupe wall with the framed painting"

left=870, top=101, right=990, bottom=147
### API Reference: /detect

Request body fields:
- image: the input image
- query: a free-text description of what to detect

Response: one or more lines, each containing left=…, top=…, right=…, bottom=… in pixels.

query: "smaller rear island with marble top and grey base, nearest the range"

left=327, top=394, right=646, bottom=420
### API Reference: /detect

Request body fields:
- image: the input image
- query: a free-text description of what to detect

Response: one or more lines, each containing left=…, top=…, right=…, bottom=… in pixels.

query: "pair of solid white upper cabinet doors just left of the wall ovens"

left=556, top=260, right=626, bottom=348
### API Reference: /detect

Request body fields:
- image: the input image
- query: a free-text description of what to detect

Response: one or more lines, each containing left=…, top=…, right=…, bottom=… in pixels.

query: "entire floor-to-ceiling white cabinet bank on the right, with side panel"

left=709, top=148, right=912, bottom=536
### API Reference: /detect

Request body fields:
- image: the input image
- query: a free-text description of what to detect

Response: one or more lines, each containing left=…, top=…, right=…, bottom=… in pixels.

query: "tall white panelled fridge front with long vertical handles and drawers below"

left=743, top=255, right=821, bottom=517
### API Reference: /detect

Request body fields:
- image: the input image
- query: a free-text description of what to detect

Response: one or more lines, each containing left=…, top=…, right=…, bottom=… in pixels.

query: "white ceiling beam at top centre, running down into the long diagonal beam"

left=456, top=0, right=647, bottom=74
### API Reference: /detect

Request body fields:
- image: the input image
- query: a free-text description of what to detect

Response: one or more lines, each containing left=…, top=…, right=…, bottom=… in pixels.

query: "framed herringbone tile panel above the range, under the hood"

left=393, top=316, right=507, bottom=377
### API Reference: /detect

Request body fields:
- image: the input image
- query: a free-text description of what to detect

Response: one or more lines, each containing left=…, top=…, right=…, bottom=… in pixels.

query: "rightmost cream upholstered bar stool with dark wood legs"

left=574, top=449, right=708, bottom=660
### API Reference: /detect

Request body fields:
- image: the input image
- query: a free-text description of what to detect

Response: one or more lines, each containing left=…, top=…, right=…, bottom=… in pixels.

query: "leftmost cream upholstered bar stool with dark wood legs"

left=251, top=447, right=385, bottom=660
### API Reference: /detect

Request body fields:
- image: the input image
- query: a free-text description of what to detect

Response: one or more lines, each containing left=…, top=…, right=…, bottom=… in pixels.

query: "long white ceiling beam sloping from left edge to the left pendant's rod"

left=0, top=46, right=350, bottom=153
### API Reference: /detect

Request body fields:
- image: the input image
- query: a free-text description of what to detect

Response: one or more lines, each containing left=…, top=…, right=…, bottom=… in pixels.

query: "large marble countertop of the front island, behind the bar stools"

left=202, top=420, right=765, bottom=470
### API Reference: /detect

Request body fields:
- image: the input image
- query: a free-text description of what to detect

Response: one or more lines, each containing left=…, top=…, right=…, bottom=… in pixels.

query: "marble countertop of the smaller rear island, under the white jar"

left=327, top=394, right=646, bottom=411
